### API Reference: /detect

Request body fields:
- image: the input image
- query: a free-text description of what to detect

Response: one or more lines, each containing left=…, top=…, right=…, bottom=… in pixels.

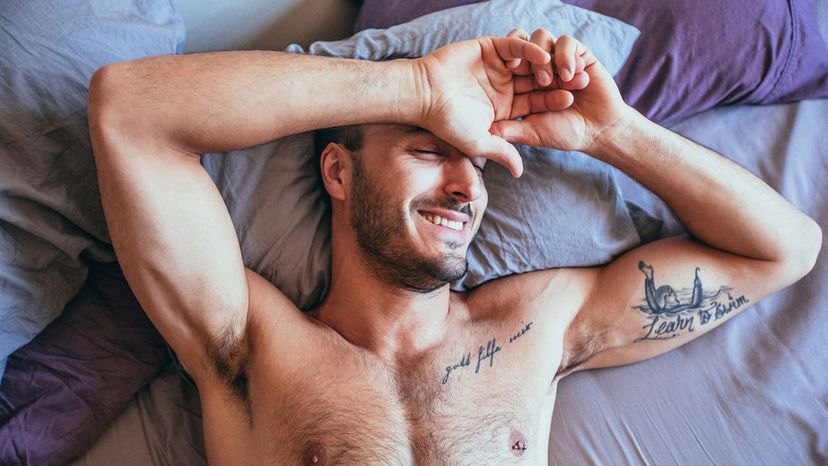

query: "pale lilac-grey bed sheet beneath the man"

left=69, top=99, right=828, bottom=466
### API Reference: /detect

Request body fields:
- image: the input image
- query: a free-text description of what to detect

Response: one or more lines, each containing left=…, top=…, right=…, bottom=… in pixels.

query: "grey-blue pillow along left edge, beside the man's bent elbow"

left=0, top=0, right=184, bottom=373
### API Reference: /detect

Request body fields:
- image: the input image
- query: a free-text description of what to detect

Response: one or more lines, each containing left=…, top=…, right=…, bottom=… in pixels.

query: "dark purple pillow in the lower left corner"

left=0, top=263, right=170, bottom=464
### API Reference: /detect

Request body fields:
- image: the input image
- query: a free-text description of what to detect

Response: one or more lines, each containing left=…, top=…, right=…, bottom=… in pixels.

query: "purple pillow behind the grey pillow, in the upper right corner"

left=356, top=0, right=828, bottom=121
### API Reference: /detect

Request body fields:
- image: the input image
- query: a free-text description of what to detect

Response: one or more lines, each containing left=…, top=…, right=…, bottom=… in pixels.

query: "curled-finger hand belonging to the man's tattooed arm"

left=492, top=29, right=631, bottom=153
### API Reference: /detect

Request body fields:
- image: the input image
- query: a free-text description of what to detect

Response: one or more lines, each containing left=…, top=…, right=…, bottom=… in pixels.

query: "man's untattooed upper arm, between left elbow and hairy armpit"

left=91, top=122, right=248, bottom=382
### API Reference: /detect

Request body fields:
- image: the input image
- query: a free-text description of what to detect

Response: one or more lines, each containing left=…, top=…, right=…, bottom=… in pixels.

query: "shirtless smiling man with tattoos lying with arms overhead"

left=89, top=30, right=822, bottom=465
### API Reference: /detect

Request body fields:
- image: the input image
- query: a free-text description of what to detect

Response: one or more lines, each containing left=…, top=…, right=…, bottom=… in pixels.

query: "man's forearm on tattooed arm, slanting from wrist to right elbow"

left=592, top=107, right=821, bottom=261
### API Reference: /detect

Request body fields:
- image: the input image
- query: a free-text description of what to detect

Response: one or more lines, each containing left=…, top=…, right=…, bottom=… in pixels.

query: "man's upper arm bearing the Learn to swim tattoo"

left=561, top=237, right=802, bottom=372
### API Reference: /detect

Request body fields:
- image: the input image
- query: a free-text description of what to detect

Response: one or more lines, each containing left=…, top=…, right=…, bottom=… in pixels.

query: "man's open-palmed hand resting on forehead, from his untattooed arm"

left=412, top=37, right=572, bottom=176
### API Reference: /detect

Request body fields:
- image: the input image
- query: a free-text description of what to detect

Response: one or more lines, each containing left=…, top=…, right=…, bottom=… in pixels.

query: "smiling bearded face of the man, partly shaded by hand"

left=342, top=125, right=488, bottom=292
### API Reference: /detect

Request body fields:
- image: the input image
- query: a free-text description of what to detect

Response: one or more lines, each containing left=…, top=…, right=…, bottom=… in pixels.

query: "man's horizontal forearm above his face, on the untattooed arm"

left=90, top=51, right=421, bottom=154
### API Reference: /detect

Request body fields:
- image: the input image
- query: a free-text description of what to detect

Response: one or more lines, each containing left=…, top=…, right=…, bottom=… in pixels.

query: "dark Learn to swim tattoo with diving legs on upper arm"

left=633, top=261, right=750, bottom=343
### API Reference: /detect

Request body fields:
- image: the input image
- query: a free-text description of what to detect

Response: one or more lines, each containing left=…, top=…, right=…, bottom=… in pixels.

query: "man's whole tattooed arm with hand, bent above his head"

left=495, top=31, right=822, bottom=375
